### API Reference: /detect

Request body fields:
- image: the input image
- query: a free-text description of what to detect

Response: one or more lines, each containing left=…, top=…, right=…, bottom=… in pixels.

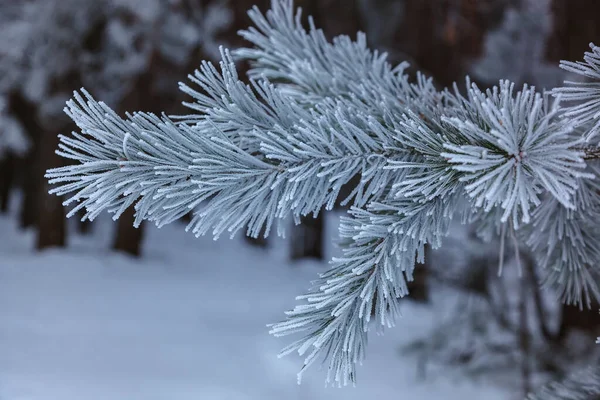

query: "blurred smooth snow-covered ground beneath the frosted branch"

left=0, top=205, right=514, bottom=400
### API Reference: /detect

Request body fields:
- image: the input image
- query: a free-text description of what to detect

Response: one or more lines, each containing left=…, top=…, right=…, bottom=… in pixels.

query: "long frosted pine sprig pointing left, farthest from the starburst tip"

left=47, top=52, right=414, bottom=236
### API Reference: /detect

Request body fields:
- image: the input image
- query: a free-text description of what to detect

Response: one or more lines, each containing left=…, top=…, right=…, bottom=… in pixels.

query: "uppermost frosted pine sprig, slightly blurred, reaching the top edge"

left=234, top=0, right=440, bottom=116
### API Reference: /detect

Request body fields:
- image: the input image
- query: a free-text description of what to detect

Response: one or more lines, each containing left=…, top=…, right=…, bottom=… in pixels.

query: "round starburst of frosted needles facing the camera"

left=441, top=81, right=591, bottom=227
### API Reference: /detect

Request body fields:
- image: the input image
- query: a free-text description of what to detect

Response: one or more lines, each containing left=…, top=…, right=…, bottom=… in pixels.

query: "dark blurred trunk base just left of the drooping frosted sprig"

left=290, top=214, right=324, bottom=260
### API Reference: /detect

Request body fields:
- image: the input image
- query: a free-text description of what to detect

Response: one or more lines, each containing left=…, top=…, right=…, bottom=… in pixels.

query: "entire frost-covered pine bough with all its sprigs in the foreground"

left=46, top=0, right=600, bottom=385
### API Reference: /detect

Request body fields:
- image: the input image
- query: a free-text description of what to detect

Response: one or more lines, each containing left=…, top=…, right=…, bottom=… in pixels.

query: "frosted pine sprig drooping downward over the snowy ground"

left=271, top=191, right=460, bottom=386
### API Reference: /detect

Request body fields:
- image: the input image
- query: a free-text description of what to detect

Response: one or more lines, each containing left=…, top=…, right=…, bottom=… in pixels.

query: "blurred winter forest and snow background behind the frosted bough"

left=0, top=0, right=600, bottom=400
